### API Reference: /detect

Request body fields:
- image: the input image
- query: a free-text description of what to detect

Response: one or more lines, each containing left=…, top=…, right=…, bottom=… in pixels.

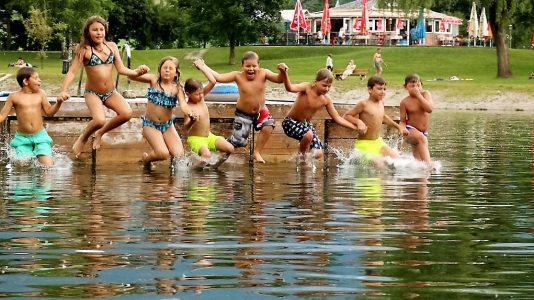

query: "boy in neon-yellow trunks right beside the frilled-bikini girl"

left=184, top=59, right=234, bottom=167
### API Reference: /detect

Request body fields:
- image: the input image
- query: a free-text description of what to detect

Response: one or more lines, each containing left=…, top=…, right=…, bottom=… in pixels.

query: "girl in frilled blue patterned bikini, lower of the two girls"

left=128, top=56, right=185, bottom=165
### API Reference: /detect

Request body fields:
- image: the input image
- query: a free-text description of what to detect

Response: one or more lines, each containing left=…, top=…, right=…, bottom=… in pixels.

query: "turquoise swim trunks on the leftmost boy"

left=10, top=128, right=52, bottom=158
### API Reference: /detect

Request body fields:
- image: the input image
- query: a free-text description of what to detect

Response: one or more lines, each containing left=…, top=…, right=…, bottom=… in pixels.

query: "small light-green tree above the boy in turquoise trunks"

left=24, top=7, right=53, bottom=68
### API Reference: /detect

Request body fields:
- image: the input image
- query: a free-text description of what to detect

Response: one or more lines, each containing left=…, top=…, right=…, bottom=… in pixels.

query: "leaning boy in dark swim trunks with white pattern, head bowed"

left=278, top=64, right=357, bottom=159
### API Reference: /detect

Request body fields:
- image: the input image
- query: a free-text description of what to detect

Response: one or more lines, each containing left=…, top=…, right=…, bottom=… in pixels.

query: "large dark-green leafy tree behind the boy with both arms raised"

left=186, top=0, right=289, bottom=64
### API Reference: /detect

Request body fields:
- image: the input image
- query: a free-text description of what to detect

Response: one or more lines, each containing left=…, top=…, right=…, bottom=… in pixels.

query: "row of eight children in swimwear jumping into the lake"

left=0, top=16, right=432, bottom=166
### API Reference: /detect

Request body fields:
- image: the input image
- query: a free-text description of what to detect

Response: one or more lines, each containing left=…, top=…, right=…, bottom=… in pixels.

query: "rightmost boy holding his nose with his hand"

left=400, top=74, right=432, bottom=165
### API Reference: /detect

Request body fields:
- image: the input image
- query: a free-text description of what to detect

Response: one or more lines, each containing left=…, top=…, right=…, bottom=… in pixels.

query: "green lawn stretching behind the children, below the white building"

left=0, top=46, right=534, bottom=95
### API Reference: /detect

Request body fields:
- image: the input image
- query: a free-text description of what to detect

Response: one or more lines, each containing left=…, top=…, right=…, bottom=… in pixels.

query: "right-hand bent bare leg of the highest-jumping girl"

left=93, top=92, right=133, bottom=150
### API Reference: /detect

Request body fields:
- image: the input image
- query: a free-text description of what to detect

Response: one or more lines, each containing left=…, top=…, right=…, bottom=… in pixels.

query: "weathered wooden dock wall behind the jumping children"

left=0, top=97, right=398, bottom=163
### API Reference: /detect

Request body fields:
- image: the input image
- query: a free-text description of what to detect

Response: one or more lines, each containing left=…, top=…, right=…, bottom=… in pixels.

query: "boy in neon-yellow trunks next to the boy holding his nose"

left=343, top=76, right=408, bottom=167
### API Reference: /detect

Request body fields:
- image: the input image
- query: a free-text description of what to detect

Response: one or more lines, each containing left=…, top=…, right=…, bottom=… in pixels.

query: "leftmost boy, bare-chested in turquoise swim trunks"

left=0, top=67, right=63, bottom=166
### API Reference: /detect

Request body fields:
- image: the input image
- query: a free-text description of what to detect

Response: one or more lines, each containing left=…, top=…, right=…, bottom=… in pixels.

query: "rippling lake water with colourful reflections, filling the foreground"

left=0, top=113, right=534, bottom=299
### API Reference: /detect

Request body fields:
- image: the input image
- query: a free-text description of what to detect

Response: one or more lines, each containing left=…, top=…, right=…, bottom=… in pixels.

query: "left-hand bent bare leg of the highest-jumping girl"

left=72, top=94, right=106, bottom=157
